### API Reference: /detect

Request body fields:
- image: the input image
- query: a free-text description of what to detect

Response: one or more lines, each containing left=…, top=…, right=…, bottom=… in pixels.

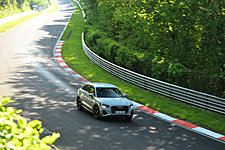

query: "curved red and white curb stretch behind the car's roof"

left=53, top=41, right=89, bottom=83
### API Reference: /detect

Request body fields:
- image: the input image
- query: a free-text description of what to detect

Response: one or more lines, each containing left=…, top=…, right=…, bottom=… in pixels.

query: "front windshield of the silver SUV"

left=96, top=88, right=122, bottom=98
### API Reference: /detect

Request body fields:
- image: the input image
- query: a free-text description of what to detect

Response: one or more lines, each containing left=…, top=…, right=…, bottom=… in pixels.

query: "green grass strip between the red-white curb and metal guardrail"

left=62, top=3, right=225, bottom=134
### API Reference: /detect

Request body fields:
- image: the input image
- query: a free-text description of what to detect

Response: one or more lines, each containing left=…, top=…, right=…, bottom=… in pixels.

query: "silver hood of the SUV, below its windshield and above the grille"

left=96, top=98, right=132, bottom=106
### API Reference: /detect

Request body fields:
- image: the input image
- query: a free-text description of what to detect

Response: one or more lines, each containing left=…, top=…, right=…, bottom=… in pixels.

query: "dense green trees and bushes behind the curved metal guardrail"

left=80, top=0, right=225, bottom=97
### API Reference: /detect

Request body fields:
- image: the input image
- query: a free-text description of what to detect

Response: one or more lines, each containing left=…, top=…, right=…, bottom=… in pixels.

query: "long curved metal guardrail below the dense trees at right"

left=82, top=33, right=225, bottom=115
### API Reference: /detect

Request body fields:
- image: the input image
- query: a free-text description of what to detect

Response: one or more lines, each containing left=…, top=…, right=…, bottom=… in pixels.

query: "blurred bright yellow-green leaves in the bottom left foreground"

left=0, top=97, right=60, bottom=150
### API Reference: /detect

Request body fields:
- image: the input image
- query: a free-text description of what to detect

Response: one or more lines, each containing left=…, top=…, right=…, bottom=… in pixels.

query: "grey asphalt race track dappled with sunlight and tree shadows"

left=0, top=0, right=225, bottom=150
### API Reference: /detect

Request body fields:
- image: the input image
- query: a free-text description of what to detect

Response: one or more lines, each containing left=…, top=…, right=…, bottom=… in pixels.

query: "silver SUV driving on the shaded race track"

left=77, top=83, right=134, bottom=120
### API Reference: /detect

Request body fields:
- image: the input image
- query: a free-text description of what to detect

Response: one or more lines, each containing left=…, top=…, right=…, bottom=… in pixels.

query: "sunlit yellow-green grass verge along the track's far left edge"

left=0, top=0, right=58, bottom=33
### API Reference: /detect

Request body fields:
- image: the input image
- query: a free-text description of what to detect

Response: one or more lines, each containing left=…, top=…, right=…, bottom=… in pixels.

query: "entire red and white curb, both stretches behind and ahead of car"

left=54, top=41, right=225, bottom=144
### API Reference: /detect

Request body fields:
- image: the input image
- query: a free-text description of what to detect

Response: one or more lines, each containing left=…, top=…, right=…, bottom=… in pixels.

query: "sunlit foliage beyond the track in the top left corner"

left=0, top=0, right=49, bottom=18
